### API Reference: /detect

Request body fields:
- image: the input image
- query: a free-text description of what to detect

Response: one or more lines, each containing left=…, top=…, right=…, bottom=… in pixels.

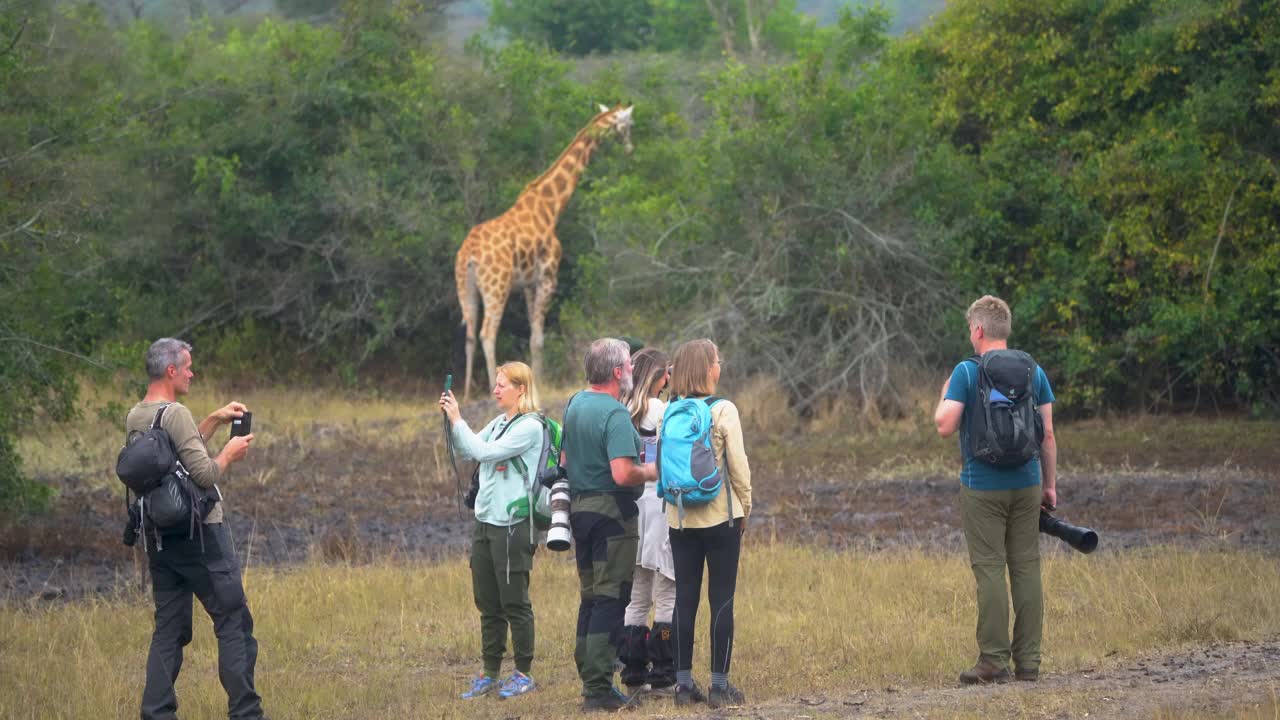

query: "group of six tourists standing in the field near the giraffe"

left=125, top=296, right=1057, bottom=720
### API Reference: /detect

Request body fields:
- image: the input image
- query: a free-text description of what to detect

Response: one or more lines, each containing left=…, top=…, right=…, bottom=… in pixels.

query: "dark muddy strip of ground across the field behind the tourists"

left=0, top=404, right=1280, bottom=602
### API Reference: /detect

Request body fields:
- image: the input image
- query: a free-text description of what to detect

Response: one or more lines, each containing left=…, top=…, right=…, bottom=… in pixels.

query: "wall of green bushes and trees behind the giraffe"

left=0, top=0, right=1280, bottom=502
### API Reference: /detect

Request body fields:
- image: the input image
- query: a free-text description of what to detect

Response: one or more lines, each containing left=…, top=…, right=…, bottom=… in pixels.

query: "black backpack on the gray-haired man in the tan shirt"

left=115, top=404, right=218, bottom=548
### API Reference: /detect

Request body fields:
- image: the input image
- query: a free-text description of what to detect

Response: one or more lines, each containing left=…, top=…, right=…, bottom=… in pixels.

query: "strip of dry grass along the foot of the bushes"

left=18, top=368, right=1280, bottom=491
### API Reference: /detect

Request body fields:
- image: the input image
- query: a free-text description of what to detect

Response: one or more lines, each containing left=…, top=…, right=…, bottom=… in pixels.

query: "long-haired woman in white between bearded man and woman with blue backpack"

left=618, top=347, right=676, bottom=694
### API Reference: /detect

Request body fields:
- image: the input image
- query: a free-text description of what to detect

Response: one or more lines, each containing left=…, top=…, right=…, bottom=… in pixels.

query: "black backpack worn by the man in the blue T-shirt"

left=968, top=350, right=1044, bottom=468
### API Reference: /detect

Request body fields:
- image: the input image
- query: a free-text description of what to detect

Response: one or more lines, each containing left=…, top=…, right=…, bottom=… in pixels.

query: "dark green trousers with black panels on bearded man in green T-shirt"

left=570, top=493, right=640, bottom=697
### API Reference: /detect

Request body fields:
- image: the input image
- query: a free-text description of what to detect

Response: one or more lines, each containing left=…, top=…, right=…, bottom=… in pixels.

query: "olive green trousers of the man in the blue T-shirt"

left=960, top=486, right=1044, bottom=670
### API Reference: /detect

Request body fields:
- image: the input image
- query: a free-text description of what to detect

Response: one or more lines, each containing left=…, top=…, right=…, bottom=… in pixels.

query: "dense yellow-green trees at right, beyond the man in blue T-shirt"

left=913, top=0, right=1280, bottom=409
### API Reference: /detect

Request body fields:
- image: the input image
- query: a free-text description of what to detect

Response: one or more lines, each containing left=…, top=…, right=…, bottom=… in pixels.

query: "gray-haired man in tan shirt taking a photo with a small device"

left=124, top=337, right=262, bottom=720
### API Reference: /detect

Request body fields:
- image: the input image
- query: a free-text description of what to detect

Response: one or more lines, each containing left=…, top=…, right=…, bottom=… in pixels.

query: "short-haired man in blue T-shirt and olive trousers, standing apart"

left=933, top=295, right=1057, bottom=684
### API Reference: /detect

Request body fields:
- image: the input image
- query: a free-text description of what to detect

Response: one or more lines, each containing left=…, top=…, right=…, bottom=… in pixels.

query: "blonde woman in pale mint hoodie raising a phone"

left=440, top=363, right=543, bottom=700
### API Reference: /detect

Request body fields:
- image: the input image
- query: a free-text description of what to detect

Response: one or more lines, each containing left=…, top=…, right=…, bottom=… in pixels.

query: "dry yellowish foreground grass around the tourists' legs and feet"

left=0, top=538, right=1280, bottom=719
